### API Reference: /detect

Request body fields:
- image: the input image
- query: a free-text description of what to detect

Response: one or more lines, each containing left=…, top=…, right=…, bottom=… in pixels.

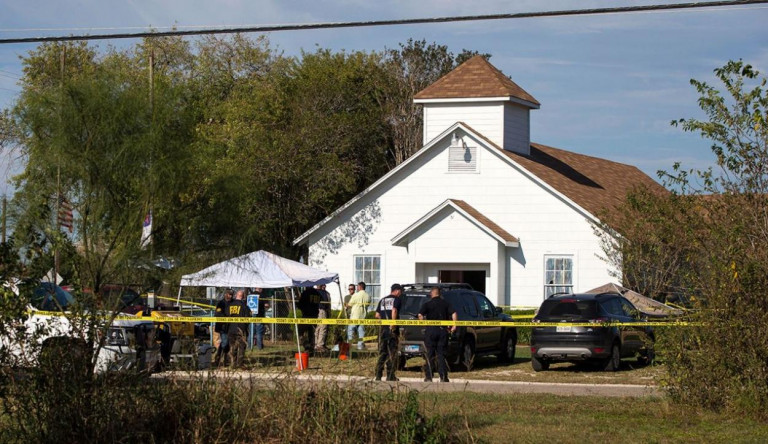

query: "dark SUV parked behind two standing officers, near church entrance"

left=400, top=284, right=517, bottom=371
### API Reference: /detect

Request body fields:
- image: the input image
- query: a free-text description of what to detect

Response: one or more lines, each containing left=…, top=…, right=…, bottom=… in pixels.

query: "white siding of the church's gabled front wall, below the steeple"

left=308, top=127, right=612, bottom=306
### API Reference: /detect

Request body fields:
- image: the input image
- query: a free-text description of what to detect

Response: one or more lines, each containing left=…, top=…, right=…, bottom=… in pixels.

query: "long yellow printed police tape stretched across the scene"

left=33, top=311, right=704, bottom=327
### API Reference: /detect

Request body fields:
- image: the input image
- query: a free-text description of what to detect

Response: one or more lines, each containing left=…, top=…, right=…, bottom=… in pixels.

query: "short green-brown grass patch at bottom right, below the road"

left=420, top=393, right=768, bottom=443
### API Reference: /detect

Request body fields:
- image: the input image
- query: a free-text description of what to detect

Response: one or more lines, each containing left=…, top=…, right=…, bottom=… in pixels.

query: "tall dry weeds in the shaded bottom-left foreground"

left=0, top=366, right=471, bottom=443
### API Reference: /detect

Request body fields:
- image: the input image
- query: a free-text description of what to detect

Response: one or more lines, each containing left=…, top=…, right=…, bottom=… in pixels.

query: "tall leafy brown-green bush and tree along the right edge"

left=609, top=61, right=768, bottom=418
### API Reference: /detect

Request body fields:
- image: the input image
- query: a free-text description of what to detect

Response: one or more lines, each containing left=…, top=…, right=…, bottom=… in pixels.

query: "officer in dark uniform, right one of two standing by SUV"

left=419, top=287, right=458, bottom=382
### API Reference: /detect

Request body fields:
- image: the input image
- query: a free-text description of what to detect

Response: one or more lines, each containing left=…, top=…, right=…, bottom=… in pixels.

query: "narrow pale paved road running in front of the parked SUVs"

left=153, top=371, right=663, bottom=397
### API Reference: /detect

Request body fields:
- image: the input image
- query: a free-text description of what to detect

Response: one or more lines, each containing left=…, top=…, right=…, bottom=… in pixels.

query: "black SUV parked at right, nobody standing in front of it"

left=531, top=293, right=654, bottom=372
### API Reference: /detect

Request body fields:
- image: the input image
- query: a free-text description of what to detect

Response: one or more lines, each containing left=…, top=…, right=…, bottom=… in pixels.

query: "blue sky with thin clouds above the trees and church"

left=0, top=0, right=768, bottom=194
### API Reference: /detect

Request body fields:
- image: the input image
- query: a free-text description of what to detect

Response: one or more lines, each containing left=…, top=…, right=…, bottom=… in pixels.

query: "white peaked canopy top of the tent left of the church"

left=181, top=250, right=339, bottom=288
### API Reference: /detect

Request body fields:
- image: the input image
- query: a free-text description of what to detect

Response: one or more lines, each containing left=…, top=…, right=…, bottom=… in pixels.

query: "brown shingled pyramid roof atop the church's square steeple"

left=414, top=55, right=540, bottom=108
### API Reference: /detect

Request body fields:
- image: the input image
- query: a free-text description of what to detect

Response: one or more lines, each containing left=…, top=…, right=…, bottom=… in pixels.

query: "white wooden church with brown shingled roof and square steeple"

left=294, top=56, right=659, bottom=306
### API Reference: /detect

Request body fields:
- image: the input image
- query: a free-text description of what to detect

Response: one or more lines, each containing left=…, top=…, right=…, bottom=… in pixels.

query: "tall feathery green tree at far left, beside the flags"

left=7, top=43, right=198, bottom=288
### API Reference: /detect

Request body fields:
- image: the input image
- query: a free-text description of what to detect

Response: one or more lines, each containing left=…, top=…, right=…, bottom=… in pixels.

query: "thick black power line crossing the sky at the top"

left=0, top=0, right=768, bottom=44
